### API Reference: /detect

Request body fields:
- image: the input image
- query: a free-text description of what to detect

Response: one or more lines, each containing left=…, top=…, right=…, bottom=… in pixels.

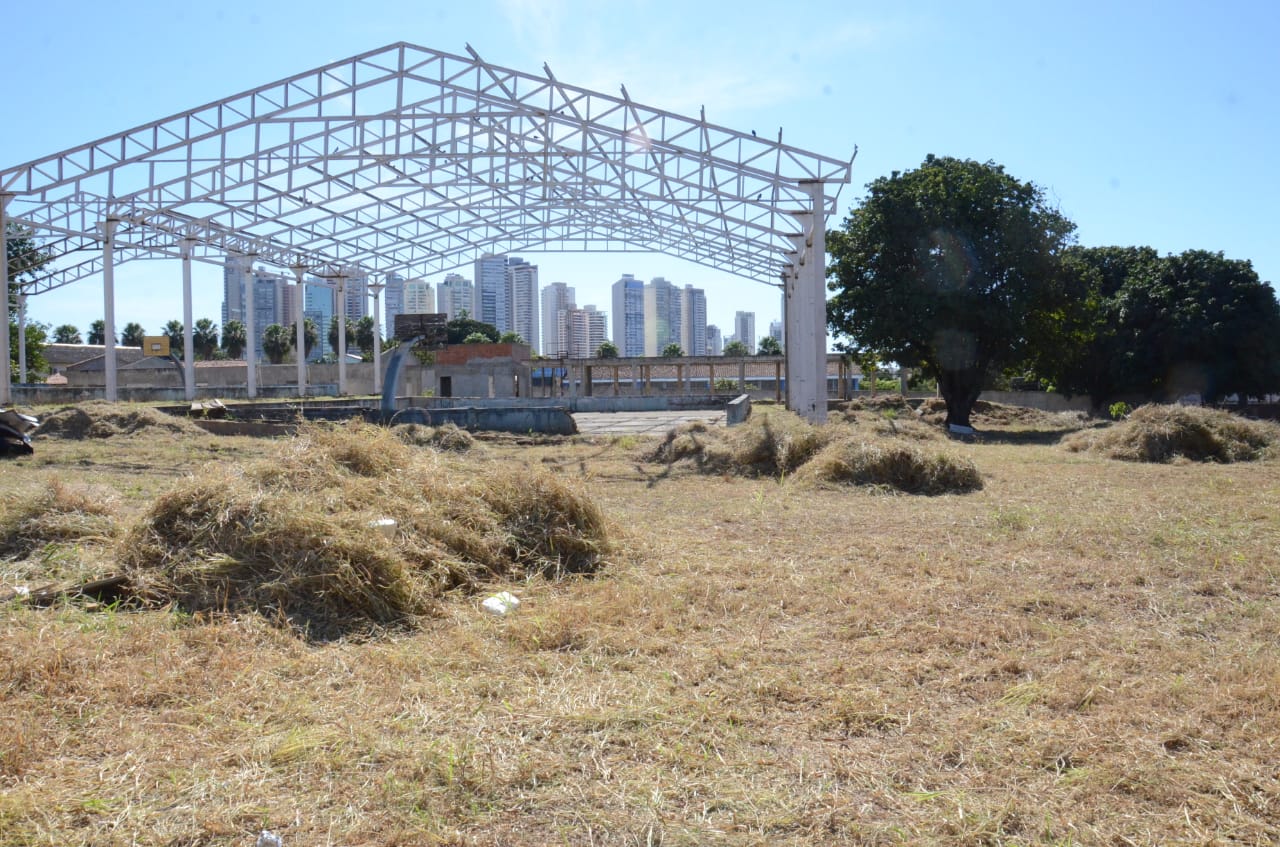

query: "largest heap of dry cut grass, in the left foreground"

left=122, top=422, right=609, bottom=640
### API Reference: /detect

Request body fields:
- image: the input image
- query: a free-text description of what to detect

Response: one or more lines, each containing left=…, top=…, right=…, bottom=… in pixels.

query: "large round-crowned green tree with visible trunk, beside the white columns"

left=827, top=156, right=1074, bottom=427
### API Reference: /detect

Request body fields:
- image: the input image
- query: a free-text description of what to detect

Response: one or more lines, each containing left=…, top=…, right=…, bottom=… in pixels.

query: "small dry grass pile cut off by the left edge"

left=0, top=481, right=119, bottom=559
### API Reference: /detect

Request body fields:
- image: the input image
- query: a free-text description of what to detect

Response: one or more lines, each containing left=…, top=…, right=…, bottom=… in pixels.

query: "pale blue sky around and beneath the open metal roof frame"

left=0, top=0, right=1280, bottom=348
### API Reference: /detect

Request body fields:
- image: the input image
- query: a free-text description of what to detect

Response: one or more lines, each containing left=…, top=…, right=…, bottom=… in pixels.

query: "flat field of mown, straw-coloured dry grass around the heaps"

left=0, top=411, right=1280, bottom=847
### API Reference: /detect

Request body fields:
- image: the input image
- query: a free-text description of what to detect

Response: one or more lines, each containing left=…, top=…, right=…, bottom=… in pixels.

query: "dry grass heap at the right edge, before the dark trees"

left=1062, top=404, right=1280, bottom=462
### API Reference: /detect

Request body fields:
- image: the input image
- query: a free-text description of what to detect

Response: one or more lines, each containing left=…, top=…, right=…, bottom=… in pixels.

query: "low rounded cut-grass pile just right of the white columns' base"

left=801, top=438, right=982, bottom=495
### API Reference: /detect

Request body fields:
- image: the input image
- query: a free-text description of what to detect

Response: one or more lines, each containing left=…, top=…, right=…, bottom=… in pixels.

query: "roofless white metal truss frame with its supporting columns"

left=0, top=42, right=856, bottom=420
